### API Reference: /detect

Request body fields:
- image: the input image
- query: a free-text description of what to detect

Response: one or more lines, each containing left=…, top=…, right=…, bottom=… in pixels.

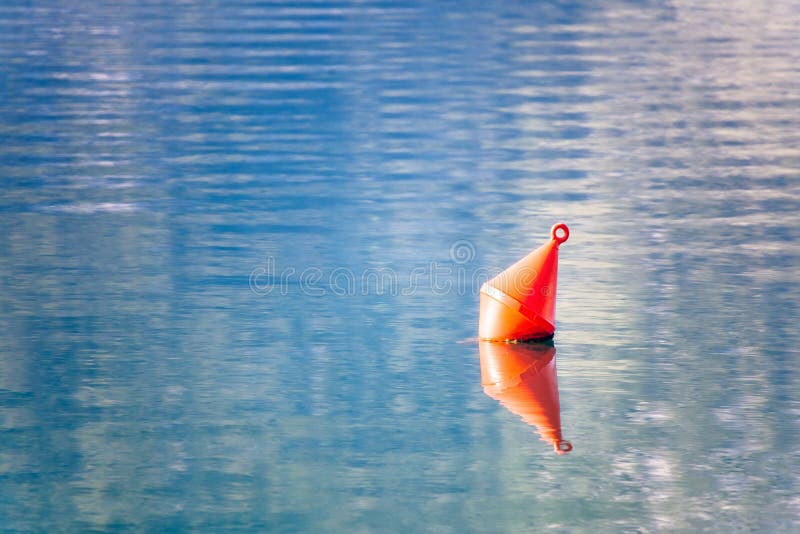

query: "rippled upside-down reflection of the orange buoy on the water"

left=479, top=341, right=572, bottom=454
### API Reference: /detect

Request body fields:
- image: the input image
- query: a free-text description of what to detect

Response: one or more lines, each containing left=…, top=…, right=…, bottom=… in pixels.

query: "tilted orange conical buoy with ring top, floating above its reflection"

left=478, top=223, right=569, bottom=341
